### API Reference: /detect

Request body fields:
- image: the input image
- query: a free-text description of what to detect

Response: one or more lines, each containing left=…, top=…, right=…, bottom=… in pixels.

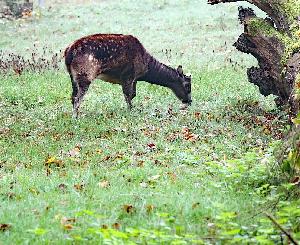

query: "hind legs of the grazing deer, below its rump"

left=71, top=74, right=91, bottom=118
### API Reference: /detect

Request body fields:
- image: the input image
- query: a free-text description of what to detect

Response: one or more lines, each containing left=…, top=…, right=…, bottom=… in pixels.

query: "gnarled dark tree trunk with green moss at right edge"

left=208, top=0, right=300, bottom=172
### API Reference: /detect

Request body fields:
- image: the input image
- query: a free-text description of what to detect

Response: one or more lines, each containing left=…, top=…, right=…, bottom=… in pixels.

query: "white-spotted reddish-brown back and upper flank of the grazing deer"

left=65, top=34, right=146, bottom=77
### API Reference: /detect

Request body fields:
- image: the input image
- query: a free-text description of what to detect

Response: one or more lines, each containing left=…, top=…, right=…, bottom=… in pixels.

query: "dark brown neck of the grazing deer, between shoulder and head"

left=138, top=56, right=178, bottom=88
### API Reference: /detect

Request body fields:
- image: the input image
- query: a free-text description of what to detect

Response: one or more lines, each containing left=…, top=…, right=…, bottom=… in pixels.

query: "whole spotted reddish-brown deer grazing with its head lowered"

left=65, top=34, right=192, bottom=117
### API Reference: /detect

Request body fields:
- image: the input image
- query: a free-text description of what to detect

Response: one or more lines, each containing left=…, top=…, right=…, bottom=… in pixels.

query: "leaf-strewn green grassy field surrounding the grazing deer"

left=0, top=0, right=292, bottom=244
